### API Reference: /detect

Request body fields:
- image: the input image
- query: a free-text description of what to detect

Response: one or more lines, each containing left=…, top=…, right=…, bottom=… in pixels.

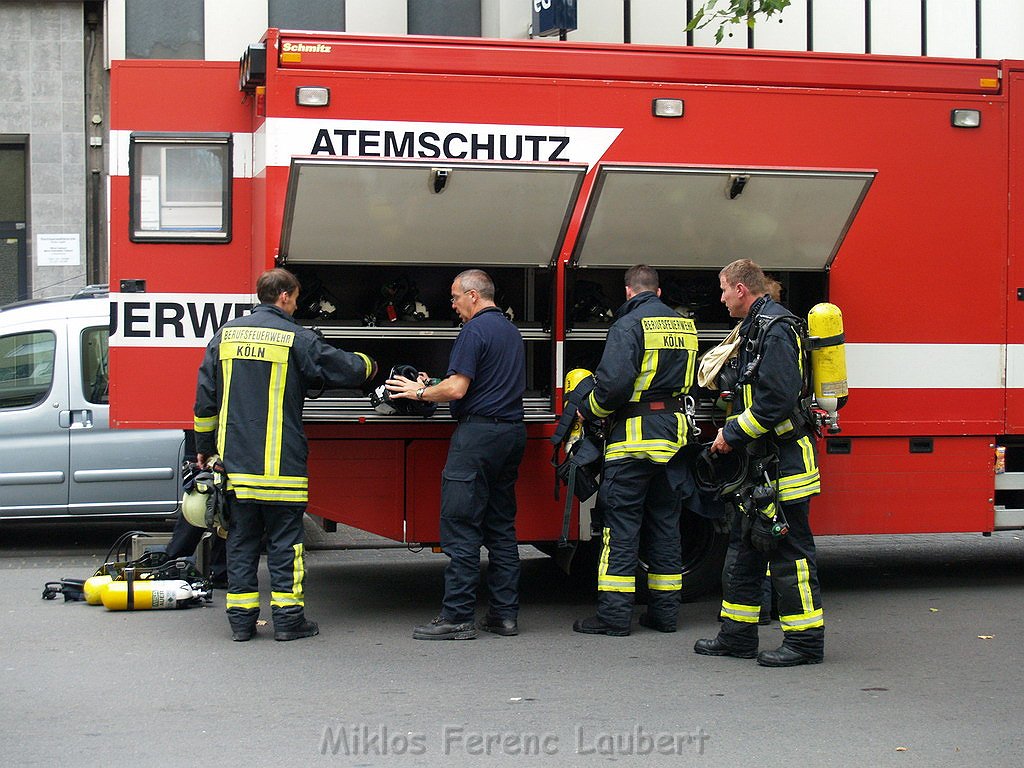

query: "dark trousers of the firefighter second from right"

left=597, top=459, right=683, bottom=629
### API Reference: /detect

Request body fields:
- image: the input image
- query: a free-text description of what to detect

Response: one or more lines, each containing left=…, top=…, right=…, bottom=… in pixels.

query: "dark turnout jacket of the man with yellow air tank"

left=723, top=296, right=821, bottom=504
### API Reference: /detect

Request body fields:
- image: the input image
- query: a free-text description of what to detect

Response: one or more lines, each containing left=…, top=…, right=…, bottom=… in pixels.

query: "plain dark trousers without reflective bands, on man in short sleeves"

left=440, top=422, right=526, bottom=623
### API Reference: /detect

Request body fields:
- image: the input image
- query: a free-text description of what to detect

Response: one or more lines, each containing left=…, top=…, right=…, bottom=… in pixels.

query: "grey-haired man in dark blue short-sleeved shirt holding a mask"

left=386, top=269, right=526, bottom=640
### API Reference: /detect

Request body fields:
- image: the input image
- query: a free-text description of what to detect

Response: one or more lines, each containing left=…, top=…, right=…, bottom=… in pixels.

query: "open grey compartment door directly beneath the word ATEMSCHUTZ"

left=280, top=158, right=587, bottom=266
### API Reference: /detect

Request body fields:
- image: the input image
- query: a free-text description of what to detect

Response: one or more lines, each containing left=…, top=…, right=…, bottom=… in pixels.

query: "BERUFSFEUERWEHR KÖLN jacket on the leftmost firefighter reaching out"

left=195, top=304, right=374, bottom=506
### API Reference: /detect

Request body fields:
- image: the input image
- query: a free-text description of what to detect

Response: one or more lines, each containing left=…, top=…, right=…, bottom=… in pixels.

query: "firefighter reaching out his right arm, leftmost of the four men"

left=195, top=269, right=377, bottom=641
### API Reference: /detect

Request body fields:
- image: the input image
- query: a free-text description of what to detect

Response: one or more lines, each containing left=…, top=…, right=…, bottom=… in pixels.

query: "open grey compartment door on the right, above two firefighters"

left=572, top=164, right=874, bottom=270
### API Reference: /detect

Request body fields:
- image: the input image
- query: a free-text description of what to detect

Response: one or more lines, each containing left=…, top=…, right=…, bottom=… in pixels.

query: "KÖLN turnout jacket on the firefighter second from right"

left=580, top=291, right=697, bottom=464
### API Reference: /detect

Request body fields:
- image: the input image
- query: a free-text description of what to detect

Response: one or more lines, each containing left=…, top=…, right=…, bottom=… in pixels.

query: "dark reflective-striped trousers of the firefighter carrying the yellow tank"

left=719, top=499, right=825, bottom=658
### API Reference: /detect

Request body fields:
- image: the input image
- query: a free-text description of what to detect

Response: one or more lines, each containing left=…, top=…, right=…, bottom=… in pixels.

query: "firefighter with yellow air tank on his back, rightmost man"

left=693, top=259, right=824, bottom=667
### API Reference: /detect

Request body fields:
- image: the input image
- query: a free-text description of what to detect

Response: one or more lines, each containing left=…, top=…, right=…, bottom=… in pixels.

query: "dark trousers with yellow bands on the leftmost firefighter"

left=225, top=495, right=305, bottom=632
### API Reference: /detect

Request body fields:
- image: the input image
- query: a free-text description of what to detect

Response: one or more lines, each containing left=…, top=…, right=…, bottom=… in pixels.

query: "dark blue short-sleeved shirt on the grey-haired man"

left=446, top=307, right=526, bottom=421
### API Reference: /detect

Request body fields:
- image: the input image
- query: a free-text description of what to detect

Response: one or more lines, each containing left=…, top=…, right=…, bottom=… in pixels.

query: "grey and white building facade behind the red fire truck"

left=0, top=0, right=1024, bottom=304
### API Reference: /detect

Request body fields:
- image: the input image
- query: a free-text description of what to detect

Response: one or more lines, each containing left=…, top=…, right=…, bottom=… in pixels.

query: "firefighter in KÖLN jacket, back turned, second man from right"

left=572, top=264, right=697, bottom=636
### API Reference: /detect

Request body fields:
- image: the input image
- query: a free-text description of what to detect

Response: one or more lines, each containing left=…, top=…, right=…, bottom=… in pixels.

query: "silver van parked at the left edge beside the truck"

left=0, top=287, right=184, bottom=519
